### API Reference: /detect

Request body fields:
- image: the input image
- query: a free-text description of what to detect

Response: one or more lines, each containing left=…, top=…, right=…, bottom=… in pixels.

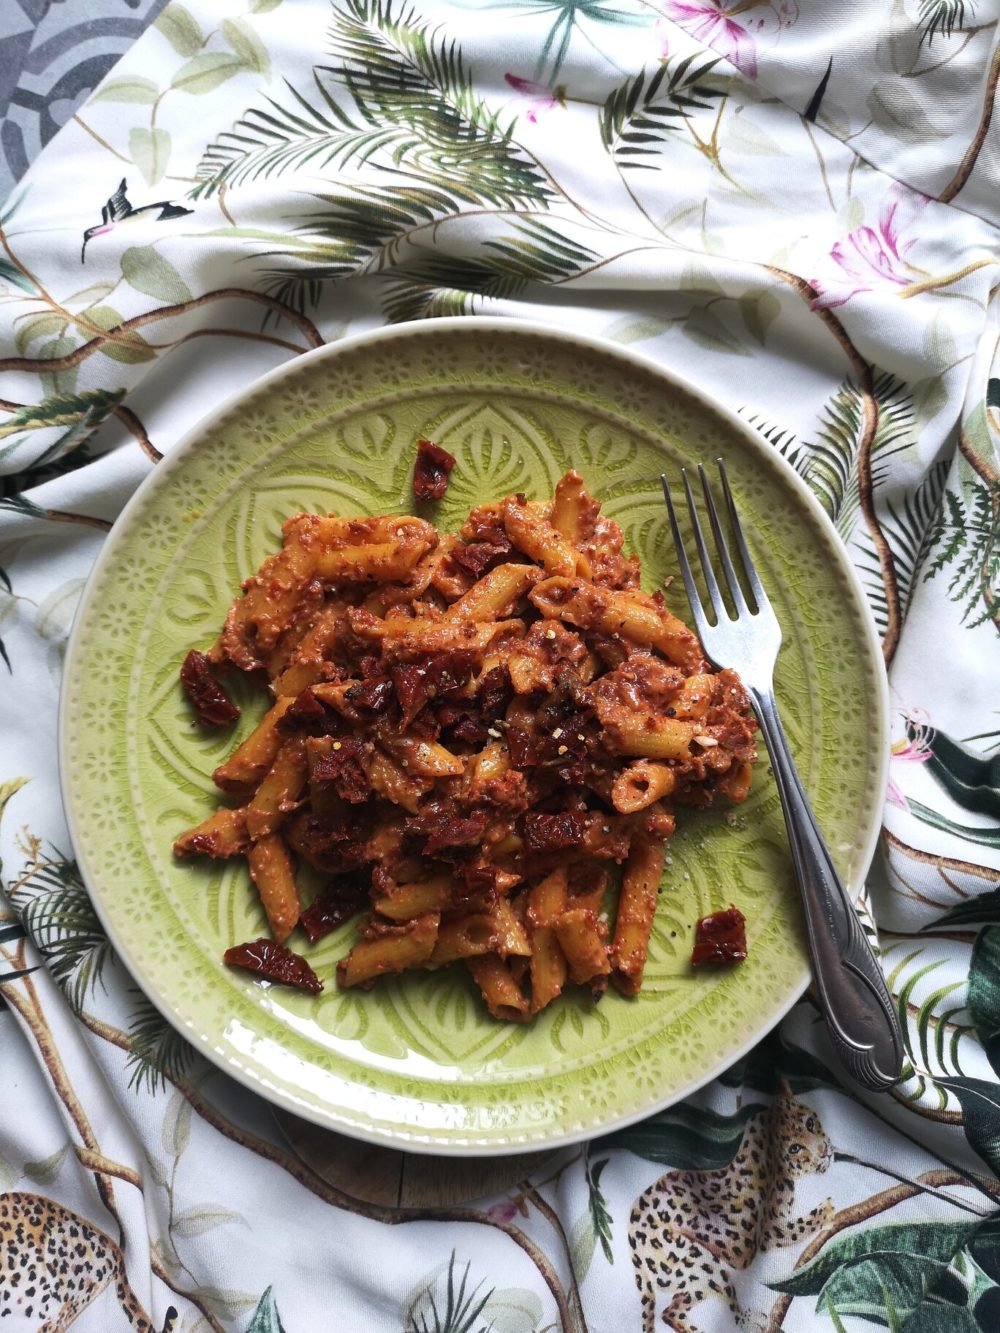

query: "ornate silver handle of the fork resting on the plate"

left=748, top=686, right=903, bottom=1092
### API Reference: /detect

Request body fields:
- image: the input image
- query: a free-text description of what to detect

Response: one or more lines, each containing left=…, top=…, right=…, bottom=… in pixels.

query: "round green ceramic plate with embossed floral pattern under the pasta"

left=61, top=320, right=887, bottom=1153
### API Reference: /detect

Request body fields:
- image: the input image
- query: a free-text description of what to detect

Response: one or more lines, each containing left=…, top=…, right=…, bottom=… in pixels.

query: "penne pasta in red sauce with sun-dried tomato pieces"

left=175, top=461, right=756, bottom=1021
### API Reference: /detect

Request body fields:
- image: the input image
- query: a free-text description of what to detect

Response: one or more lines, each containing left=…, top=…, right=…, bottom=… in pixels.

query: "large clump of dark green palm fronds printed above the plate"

left=191, top=0, right=608, bottom=320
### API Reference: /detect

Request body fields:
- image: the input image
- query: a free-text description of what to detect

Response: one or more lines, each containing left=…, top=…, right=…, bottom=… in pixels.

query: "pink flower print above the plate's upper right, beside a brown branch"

left=811, top=185, right=928, bottom=311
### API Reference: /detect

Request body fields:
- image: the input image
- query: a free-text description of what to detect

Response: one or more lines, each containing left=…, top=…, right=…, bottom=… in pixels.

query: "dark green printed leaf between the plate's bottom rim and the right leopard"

left=593, top=1102, right=764, bottom=1170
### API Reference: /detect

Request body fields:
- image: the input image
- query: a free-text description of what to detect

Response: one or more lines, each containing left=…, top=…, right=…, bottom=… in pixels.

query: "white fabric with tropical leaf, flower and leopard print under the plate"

left=0, top=0, right=1000, bottom=1333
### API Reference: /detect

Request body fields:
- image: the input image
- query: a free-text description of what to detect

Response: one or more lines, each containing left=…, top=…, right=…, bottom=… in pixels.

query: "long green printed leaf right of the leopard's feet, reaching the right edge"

left=767, top=1218, right=1000, bottom=1296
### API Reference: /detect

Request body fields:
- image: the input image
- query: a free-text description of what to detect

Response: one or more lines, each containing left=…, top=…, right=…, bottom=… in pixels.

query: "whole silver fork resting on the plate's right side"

left=660, top=459, right=903, bottom=1092
